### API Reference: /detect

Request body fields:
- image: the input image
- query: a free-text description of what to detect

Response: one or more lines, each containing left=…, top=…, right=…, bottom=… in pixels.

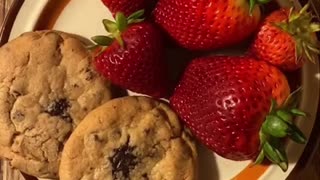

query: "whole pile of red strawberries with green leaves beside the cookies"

left=92, top=0, right=320, bottom=171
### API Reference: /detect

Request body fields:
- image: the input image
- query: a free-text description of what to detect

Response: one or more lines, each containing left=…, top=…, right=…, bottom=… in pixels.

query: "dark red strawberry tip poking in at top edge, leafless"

left=102, top=0, right=155, bottom=16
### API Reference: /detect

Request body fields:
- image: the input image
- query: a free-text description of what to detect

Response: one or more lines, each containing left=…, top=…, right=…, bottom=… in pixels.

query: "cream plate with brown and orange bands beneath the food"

left=5, top=0, right=320, bottom=180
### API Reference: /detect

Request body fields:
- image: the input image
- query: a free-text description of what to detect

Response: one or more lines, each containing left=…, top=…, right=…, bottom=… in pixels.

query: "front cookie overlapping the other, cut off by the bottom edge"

left=59, top=96, right=197, bottom=180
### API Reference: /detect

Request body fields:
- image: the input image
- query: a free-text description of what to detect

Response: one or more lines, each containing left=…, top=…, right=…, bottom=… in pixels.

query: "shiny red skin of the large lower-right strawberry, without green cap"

left=170, top=57, right=290, bottom=161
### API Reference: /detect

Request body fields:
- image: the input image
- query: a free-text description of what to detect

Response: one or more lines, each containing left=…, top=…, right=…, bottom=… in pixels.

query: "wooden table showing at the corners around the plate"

left=0, top=0, right=320, bottom=180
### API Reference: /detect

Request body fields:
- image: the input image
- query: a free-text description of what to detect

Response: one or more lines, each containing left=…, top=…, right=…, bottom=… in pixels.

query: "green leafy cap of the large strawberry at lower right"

left=255, top=88, right=307, bottom=171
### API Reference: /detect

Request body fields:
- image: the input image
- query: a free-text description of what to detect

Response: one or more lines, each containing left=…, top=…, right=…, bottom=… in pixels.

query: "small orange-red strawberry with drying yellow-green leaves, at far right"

left=250, top=6, right=320, bottom=71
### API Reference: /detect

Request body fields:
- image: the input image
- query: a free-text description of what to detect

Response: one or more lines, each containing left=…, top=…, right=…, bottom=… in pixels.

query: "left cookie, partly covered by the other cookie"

left=0, top=31, right=111, bottom=178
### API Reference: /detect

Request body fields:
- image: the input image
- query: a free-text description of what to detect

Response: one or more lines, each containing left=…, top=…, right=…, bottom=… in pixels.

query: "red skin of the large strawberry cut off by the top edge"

left=154, top=0, right=260, bottom=50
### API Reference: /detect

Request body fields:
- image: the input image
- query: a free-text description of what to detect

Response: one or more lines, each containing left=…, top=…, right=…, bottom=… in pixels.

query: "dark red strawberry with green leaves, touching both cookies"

left=92, top=11, right=168, bottom=97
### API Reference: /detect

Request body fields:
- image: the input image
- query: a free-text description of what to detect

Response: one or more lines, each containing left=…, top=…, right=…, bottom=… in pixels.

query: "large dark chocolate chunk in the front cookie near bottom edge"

left=109, top=138, right=138, bottom=178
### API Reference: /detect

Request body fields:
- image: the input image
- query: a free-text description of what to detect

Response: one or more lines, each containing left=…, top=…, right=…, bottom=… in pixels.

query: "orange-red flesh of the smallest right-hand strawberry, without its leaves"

left=251, top=9, right=303, bottom=71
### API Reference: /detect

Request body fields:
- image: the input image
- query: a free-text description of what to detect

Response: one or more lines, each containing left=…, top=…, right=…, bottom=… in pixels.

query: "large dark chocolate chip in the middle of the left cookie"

left=45, top=99, right=72, bottom=122
